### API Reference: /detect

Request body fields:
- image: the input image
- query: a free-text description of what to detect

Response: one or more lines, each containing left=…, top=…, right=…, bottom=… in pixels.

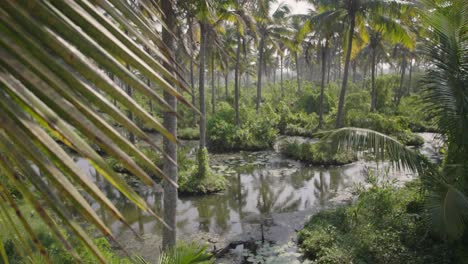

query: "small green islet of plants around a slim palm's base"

left=178, top=148, right=226, bottom=194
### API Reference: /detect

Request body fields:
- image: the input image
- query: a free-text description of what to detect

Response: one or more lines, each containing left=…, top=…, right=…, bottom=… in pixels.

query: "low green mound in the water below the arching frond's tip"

left=281, top=141, right=357, bottom=165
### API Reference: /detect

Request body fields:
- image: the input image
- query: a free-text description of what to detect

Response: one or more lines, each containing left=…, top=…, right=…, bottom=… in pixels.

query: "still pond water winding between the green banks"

left=76, top=133, right=439, bottom=263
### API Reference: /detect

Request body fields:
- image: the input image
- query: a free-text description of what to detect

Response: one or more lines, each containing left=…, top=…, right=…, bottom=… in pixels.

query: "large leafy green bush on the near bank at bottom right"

left=299, top=183, right=456, bottom=264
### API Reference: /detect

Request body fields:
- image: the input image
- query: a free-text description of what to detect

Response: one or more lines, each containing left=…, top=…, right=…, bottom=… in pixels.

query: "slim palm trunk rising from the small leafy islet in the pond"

left=198, top=23, right=207, bottom=150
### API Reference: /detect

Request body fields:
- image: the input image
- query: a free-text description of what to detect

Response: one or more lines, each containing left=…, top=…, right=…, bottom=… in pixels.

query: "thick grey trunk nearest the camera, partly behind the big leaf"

left=161, top=0, right=177, bottom=249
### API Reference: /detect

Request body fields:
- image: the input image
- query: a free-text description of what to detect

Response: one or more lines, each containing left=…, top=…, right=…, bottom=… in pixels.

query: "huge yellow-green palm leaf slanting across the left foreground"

left=0, top=0, right=190, bottom=263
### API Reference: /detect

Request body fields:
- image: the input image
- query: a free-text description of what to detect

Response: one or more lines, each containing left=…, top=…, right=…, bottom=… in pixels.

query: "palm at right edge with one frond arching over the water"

left=324, top=0, right=468, bottom=238
